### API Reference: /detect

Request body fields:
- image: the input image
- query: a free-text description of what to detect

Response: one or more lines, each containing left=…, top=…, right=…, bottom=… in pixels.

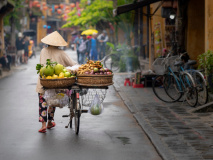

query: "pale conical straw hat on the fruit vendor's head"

left=41, top=31, right=67, bottom=46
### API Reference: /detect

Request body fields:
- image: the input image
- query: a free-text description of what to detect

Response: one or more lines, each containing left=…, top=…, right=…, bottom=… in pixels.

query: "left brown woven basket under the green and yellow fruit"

left=40, top=77, right=76, bottom=89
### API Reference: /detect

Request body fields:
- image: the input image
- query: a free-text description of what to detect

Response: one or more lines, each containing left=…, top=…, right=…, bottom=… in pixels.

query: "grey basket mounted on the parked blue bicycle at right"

left=152, top=58, right=167, bottom=75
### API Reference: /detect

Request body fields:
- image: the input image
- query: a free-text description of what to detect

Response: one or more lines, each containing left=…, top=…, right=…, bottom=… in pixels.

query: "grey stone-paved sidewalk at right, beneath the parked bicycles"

left=114, top=74, right=213, bottom=160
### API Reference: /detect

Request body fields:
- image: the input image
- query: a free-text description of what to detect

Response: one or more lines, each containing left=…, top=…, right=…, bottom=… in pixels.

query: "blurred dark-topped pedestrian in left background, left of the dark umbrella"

left=16, top=32, right=24, bottom=64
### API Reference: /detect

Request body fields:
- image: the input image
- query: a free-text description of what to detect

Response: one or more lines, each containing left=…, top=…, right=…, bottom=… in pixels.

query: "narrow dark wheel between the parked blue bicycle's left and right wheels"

left=164, top=75, right=183, bottom=102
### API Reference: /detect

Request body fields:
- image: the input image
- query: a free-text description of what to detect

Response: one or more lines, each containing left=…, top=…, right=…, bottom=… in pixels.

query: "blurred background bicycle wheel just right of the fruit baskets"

left=104, top=54, right=120, bottom=72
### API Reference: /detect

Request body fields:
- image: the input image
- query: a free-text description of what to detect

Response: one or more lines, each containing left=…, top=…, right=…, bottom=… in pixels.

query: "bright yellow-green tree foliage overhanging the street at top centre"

left=62, top=0, right=134, bottom=44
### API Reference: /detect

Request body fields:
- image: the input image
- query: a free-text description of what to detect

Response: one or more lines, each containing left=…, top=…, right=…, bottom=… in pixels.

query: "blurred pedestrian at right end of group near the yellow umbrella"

left=98, top=30, right=109, bottom=59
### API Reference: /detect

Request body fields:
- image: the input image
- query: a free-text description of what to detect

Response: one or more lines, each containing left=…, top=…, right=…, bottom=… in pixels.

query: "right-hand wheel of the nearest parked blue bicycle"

left=182, top=73, right=198, bottom=107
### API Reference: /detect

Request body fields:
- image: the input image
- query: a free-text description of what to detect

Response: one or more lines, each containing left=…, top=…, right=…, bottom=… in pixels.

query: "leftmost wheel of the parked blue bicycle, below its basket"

left=152, top=75, right=179, bottom=103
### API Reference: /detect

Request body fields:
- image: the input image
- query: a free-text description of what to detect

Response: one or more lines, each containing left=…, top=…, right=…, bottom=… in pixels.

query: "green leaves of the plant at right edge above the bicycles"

left=198, top=50, right=213, bottom=75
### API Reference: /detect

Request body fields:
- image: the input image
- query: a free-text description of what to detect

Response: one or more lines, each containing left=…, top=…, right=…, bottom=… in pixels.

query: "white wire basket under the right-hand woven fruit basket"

left=80, top=89, right=107, bottom=106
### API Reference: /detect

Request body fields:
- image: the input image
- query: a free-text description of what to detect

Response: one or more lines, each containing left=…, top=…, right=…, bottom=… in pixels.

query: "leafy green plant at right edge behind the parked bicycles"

left=198, top=50, right=213, bottom=93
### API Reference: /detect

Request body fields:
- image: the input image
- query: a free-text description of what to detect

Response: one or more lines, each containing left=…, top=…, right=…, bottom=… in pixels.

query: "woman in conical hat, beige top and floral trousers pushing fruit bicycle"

left=36, top=31, right=76, bottom=133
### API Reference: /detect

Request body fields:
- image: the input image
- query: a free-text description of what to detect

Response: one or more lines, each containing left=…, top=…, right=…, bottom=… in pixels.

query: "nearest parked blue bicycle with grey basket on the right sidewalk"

left=152, top=53, right=198, bottom=107
